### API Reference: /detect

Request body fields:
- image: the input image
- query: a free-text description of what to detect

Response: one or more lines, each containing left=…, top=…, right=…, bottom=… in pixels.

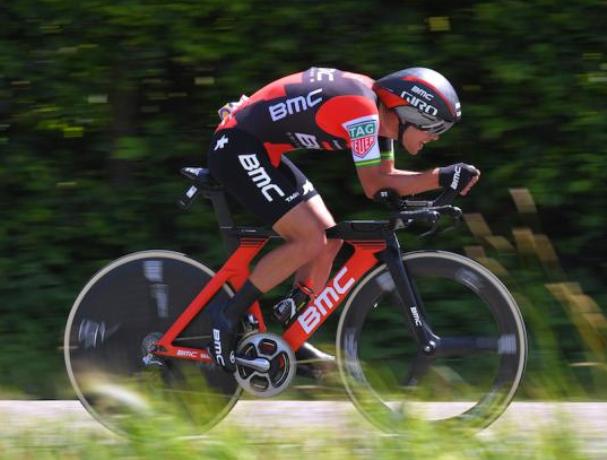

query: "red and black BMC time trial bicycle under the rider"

left=64, top=168, right=527, bottom=432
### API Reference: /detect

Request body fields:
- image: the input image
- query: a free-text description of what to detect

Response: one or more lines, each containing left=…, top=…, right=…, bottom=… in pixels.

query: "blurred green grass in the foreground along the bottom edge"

left=0, top=403, right=602, bottom=460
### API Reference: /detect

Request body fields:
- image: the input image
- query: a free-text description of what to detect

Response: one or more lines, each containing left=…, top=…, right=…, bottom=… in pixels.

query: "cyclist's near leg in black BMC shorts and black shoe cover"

left=208, top=129, right=328, bottom=370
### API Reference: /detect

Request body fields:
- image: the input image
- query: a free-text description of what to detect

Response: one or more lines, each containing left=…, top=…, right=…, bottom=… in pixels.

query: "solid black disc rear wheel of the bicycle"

left=64, top=250, right=241, bottom=436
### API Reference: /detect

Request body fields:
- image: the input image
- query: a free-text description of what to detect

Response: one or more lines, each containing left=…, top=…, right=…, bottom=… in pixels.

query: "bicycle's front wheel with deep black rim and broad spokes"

left=337, top=251, right=527, bottom=433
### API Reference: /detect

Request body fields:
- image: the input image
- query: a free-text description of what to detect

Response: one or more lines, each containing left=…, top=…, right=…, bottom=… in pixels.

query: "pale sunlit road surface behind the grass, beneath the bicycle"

left=0, top=400, right=607, bottom=459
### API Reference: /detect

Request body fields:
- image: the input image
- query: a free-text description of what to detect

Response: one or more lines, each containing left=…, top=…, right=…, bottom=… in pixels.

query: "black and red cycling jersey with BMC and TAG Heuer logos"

left=217, top=67, right=393, bottom=167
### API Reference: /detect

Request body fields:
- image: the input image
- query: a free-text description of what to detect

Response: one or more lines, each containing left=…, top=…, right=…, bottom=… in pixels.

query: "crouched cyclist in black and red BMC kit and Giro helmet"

left=208, top=67, right=480, bottom=372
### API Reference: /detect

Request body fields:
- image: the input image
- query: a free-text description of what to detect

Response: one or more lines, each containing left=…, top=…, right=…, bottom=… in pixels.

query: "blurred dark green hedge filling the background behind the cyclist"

left=0, top=0, right=607, bottom=396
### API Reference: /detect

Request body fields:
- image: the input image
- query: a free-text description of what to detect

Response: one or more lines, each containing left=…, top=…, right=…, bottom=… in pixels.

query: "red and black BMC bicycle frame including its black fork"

left=154, top=221, right=436, bottom=362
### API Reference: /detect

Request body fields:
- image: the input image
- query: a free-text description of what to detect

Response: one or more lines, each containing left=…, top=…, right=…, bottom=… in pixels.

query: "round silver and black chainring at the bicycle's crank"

left=234, top=333, right=297, bottom=398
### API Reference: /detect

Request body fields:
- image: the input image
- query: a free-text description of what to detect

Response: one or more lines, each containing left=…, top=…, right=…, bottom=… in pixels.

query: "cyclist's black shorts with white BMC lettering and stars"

left=207, top=128, right=318, bottom=226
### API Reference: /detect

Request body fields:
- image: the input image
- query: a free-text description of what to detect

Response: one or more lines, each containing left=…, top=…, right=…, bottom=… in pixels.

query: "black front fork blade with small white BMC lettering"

left=380, top=233, right=440, bottom=355
